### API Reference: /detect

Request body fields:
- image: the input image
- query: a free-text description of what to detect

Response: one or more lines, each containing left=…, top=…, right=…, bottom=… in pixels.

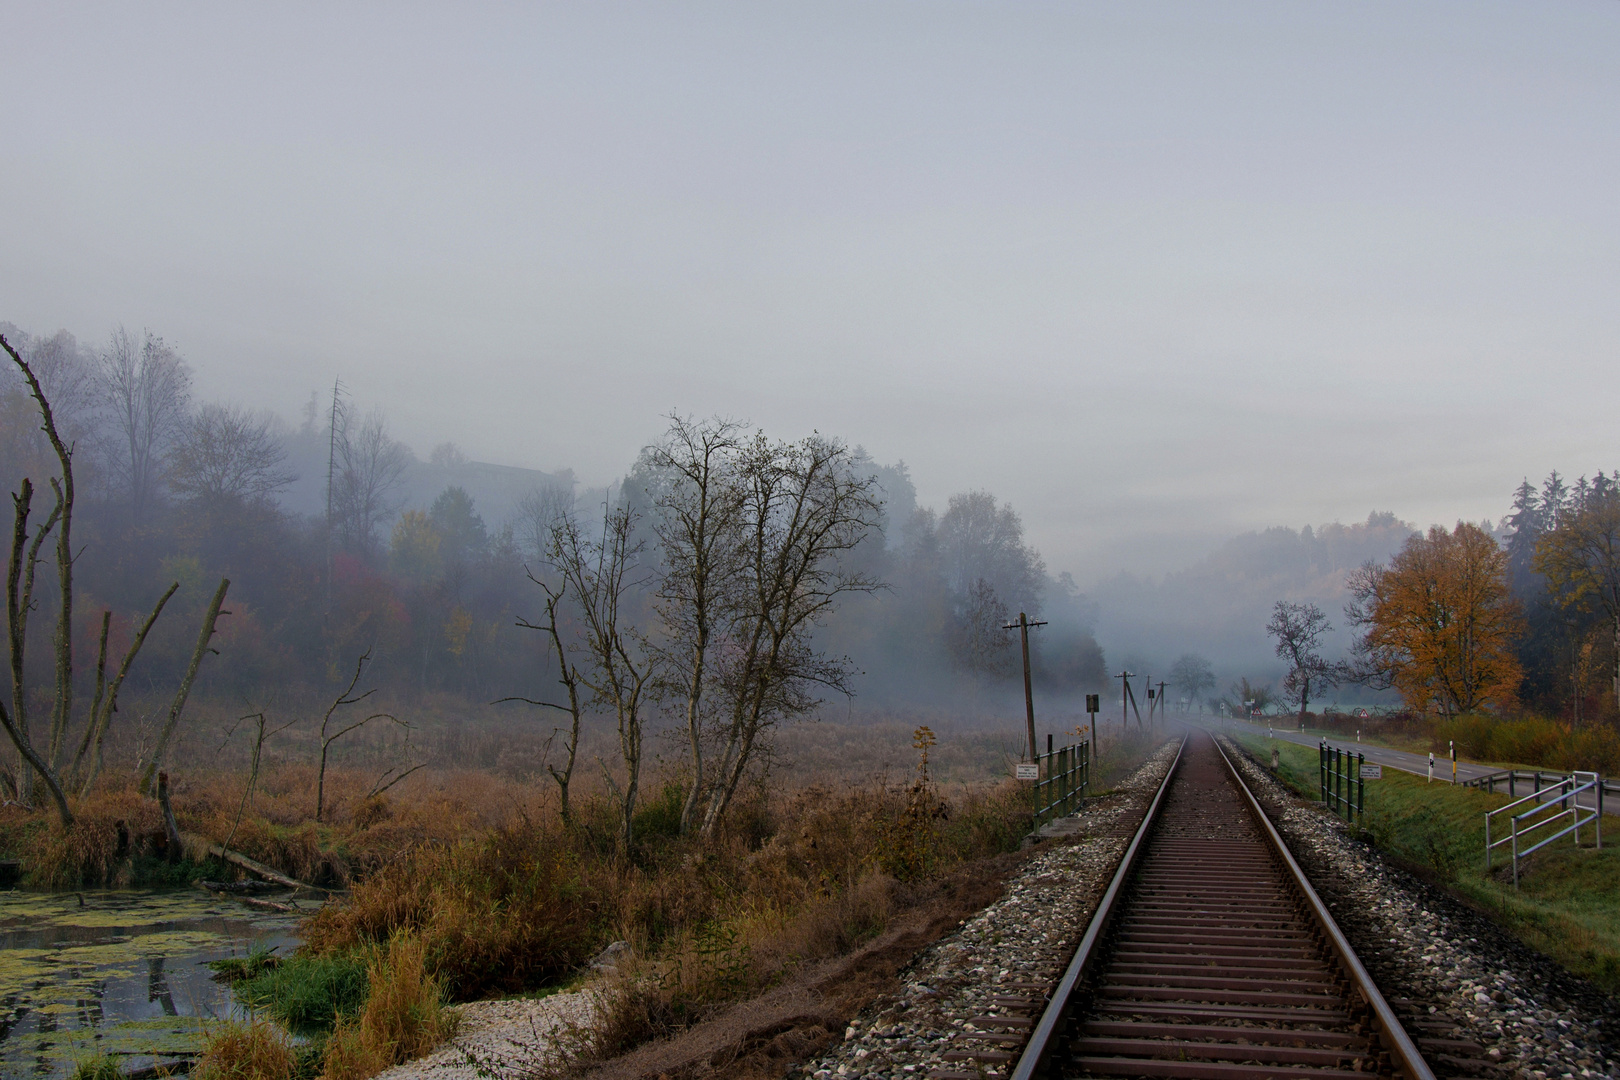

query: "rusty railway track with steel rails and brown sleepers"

left=935, top=732, right=1434, bottom=1080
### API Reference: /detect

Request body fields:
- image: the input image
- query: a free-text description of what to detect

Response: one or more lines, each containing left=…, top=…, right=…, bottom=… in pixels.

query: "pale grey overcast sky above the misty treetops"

left=0, top=0, right=1620, bottom=585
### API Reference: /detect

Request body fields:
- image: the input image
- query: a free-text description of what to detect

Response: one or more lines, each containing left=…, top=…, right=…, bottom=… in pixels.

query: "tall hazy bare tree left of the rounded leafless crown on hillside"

left=96, top=327, right=191, bottom=521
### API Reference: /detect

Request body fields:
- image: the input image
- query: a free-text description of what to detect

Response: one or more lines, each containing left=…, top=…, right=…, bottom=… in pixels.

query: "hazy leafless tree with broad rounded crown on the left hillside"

left=168, top=405, right=298, bottom=507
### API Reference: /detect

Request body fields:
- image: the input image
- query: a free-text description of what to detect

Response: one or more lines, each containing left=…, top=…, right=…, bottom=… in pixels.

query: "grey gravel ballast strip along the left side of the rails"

left=786, top=740, right=1179, bottom=1080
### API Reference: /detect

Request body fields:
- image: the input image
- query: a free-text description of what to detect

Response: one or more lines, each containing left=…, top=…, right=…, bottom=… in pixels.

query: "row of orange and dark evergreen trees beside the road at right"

left=1267, top=471, right=1620, bottom=727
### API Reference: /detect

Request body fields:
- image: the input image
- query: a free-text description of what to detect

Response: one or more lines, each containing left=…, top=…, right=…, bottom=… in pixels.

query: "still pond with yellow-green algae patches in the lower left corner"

left=0, top=889, right=298, bottom=1078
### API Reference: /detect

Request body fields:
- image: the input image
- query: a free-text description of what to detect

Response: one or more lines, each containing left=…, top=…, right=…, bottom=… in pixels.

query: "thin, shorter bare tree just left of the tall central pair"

left=551, top=507, right=653, bottom=850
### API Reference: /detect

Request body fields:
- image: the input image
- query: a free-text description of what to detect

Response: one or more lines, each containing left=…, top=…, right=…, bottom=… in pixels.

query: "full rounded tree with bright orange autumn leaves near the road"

left=1345, top=521, right=1523, bottom=716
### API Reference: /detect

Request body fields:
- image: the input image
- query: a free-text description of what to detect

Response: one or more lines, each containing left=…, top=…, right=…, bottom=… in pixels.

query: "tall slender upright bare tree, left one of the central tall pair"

left=643, top=416, right=745, bottom=832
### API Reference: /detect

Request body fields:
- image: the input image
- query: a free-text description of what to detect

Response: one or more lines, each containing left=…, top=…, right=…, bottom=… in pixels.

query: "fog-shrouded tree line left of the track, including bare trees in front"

left=0, top=325, right=1103, bottom=839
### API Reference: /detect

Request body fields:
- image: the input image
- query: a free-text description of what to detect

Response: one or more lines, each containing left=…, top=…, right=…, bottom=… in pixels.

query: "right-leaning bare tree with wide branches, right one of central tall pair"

left=703, top=434, right=883, bottom=836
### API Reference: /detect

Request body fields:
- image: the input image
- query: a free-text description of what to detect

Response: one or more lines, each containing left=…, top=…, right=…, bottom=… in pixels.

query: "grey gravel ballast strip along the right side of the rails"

left=1221, top=737, right=1620, bottom=1080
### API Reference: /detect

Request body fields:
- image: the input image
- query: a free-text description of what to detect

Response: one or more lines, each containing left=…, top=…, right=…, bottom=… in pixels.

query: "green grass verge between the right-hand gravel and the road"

left=1238, top=735, right=1620, bottom=994
